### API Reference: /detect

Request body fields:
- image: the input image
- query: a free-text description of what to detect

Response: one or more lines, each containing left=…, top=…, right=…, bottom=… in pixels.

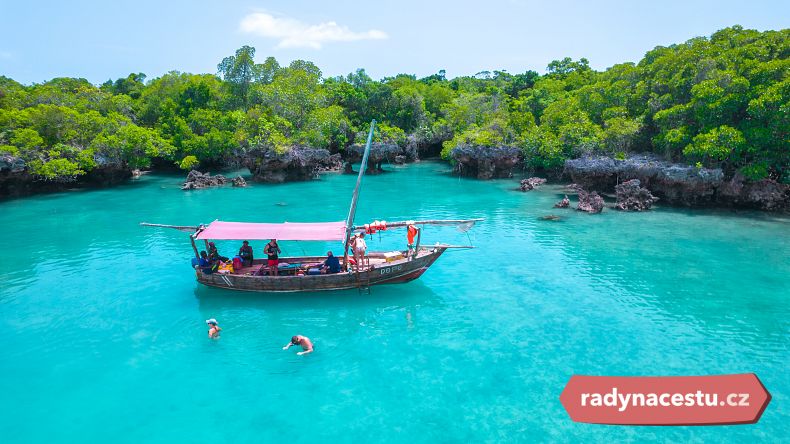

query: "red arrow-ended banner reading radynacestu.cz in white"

left=560, top=373, right=771, bottom=425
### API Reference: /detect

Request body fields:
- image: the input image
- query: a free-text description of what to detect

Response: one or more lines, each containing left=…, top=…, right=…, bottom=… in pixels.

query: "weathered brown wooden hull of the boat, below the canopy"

left=196, top=247, right=447, bottom=293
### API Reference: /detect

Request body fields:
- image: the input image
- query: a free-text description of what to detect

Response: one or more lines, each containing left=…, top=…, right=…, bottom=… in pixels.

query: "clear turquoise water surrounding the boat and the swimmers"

left=0, top=162, right=790, bottom=443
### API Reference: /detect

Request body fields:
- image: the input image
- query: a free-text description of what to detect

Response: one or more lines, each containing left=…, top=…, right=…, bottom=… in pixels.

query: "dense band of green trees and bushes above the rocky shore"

left=0, top=26, right=790, bottom=182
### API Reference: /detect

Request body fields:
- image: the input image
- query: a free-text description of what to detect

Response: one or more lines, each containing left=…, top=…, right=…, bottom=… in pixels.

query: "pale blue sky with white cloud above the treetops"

left=0, top=0, right=790, bottom=84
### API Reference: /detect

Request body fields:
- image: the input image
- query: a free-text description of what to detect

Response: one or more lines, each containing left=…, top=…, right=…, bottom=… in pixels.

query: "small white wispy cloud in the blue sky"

left=240, top=12, right=387, bottom=49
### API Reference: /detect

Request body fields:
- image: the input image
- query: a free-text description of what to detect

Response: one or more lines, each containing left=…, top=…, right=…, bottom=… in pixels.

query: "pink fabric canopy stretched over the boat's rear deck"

left=197, top=221, right=346, bottom=241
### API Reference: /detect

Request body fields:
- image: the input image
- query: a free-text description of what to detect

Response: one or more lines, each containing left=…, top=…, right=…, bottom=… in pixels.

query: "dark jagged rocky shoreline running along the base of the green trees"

left=0, top=148, right=790, bottom=212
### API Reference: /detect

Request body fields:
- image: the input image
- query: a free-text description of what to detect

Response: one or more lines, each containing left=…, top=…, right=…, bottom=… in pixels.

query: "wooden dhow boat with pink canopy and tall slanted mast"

left=141, top=120, right=482, bottom=293
